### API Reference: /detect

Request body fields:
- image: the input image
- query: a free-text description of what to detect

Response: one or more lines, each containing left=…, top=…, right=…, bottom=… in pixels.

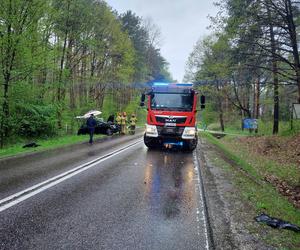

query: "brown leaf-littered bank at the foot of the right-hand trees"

left=238, top=135, right=300, bottom=169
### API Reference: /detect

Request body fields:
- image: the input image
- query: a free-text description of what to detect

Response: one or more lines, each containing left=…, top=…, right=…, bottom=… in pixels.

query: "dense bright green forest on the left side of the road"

left=0, top=0, right=171, bottom=147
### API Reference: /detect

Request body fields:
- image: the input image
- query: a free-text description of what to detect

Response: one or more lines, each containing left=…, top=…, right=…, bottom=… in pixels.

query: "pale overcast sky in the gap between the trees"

left=106, top=0, right=217, bottom=82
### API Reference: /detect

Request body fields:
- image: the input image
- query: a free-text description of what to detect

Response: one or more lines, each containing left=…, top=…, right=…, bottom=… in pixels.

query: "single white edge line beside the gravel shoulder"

left=193, top=152, right=209, bottom=250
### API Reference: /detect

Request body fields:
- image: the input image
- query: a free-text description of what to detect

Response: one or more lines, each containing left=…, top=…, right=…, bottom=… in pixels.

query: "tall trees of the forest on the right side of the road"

left=185, top=0, right=300, bottom=134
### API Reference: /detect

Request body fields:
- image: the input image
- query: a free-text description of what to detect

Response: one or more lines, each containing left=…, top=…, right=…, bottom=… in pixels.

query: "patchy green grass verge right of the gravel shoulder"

left=201, top=133, right=300, bottom=249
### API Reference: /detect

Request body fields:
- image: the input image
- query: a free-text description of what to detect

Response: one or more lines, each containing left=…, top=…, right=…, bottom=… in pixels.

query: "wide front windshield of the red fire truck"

left=151, top=93, right=193, bottom=111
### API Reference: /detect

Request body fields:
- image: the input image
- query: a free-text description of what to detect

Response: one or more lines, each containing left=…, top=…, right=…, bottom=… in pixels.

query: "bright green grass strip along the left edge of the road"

left=0, top=135, right=106, bottom=159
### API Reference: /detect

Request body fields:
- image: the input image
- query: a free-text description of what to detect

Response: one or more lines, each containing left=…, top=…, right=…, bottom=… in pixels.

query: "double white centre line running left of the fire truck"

left=0, top=140, right=142, bottom=212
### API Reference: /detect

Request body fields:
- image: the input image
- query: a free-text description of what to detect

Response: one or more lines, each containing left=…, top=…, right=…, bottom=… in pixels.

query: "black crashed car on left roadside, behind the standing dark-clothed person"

left=77, top=120, right=120, bottom=135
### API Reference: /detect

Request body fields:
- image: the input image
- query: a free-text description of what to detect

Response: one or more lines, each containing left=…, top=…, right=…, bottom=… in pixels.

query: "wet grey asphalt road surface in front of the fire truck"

left=0, top=135, right=207, bottom=250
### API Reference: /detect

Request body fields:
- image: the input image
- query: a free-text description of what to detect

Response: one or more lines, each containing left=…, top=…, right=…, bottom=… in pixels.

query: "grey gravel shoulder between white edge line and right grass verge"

left=197, top=138, right=274, bottom=250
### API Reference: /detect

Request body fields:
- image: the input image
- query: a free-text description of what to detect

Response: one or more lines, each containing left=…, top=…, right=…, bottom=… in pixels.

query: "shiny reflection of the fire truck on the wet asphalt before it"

left=144, top=150, right=194, bottom=219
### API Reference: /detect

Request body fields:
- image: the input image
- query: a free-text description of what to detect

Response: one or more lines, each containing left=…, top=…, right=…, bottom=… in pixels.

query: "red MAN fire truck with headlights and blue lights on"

left=141, top=83, right=205, bottom=151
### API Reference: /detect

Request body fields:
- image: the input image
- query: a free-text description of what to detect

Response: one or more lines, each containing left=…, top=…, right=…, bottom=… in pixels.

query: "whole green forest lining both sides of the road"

left=0, top=0, right=300, bottom=150
